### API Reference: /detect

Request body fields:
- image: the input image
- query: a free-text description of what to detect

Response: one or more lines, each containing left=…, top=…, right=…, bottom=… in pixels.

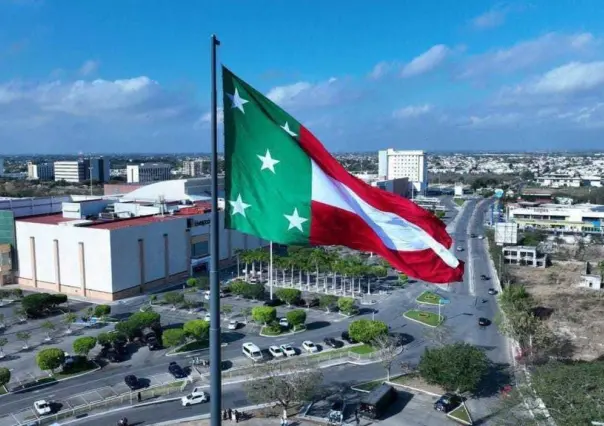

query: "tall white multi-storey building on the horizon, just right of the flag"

left=378, top=148, right=428, bottom=194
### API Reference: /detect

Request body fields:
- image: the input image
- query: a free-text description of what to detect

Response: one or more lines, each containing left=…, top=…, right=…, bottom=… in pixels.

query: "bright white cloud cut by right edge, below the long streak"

left=528, top=61, right=604, bottom=94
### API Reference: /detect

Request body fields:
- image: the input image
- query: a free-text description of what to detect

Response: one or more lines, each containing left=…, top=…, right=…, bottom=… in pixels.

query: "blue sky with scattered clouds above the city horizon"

left=0, top=0, right=604, bottom=154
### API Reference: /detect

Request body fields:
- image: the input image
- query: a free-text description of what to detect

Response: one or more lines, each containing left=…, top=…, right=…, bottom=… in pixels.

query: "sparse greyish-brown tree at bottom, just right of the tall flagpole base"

left=243, top=363, right=323, bottom=410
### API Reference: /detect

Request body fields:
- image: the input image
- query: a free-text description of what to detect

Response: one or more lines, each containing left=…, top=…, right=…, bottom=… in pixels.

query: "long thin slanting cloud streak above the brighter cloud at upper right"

left=460, top=33, right=599, bottom=78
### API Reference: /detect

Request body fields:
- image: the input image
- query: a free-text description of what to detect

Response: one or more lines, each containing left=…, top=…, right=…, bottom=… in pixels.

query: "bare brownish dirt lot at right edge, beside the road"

left=509, top=261, right=604, bottom=360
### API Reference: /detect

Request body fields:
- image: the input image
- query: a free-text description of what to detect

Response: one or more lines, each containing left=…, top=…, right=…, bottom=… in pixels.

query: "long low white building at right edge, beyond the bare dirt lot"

left=508, top=204, right=604, bottom=233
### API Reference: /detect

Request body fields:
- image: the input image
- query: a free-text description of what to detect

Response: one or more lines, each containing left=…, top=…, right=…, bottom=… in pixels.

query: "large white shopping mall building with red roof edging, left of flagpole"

left=0, top=179, right=267, bottom=300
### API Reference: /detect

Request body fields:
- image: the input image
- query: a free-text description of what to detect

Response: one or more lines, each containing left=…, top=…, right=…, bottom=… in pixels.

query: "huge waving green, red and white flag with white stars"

left=222, top=67, right=463, bottom=283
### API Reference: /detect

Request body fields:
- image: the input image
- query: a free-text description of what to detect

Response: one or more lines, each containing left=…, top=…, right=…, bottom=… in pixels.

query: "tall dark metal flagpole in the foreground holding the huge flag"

left=210, top=34, right=222, bottom=426
